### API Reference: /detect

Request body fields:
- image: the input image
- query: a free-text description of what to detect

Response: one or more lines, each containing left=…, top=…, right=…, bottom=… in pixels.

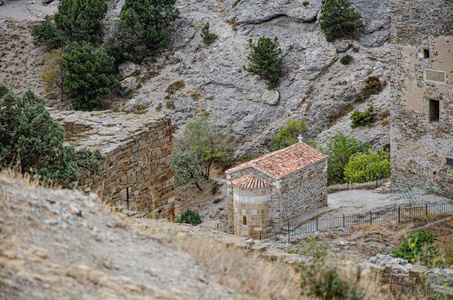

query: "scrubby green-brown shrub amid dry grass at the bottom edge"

left=300, top=239, right=365, bottom=300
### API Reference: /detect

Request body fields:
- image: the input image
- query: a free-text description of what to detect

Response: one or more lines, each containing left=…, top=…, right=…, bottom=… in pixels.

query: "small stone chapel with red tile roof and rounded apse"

left=226, top=142, right=327, bottom=238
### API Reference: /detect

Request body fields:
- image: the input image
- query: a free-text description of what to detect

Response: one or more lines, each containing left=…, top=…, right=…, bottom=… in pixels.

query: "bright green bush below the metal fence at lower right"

left=391, top=229, right=443, bottom=266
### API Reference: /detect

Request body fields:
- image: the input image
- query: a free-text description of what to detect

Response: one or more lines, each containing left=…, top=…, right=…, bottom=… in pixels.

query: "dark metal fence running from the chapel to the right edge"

left=263, top=202, right=453, bottom=242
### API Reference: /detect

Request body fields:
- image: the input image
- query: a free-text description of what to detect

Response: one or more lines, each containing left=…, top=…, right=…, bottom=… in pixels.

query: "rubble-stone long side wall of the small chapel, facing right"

left=279, top=159, right=327, bottom=221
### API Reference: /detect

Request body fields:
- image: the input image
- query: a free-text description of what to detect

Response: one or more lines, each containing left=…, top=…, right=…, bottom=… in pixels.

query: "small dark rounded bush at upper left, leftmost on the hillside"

left=31, top=16, right=68, bottom=49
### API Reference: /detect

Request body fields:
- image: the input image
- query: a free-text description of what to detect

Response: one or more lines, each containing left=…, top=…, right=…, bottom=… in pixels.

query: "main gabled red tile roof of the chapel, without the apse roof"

left=225, top=142, right=327, bottom=179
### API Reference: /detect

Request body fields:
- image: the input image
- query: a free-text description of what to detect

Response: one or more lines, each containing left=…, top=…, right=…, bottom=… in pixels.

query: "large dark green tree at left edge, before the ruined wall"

left=0, top=85, right=101, bottom=187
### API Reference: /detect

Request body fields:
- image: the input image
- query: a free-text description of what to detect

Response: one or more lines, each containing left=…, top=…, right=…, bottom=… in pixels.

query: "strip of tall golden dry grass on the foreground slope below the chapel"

left=151, top=234, right=302, bottom=299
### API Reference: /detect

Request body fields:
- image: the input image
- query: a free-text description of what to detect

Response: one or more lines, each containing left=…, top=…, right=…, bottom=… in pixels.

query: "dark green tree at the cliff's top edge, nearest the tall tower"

left=319, top=0, right=364, bottom=42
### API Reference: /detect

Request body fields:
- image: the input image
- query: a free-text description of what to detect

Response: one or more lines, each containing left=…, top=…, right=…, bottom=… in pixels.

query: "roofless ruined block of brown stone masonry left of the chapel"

left=48, top=108, right=174, bottom=218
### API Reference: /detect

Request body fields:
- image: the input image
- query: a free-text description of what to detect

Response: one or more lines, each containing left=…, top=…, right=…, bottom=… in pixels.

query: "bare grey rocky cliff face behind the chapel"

left=112, top=0, right=390, bottom=153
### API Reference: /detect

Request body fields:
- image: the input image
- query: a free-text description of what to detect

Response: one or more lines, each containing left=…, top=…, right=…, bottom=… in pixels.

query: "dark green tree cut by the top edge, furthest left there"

left=55, top=0, right=107, bottom=43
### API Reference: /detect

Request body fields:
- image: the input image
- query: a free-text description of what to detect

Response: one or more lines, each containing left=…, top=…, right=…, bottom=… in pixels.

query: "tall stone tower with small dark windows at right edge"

left=390, top=0, right=453, bottom=197
